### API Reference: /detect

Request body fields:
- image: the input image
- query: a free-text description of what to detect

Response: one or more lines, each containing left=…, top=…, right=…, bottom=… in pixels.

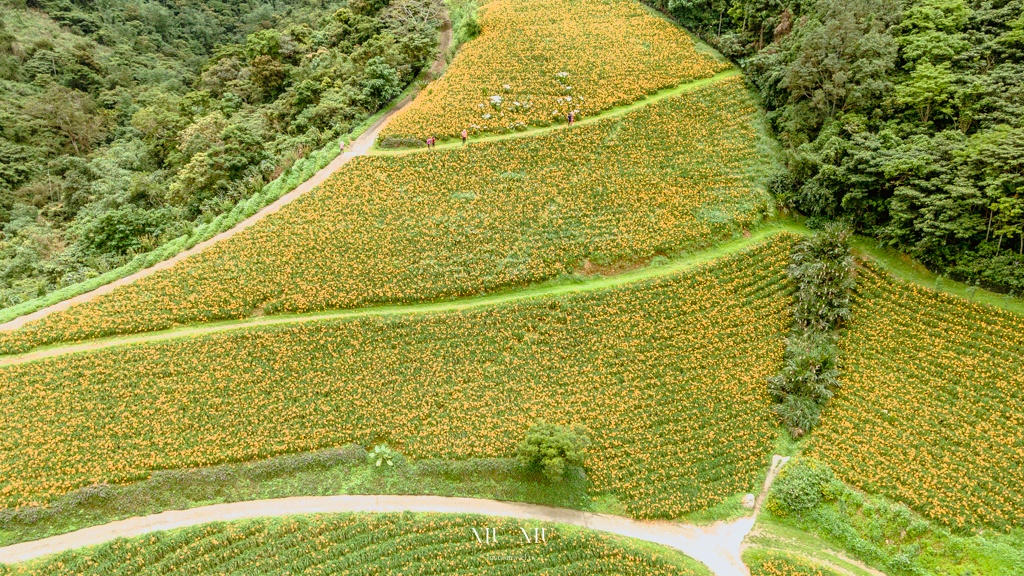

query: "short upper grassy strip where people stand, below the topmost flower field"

left=371, top=68, right=740, bottom=156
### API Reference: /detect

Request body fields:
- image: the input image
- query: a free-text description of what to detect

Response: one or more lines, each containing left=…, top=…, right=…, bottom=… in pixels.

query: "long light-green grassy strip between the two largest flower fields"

left=0, top=222, right=802, bottom=367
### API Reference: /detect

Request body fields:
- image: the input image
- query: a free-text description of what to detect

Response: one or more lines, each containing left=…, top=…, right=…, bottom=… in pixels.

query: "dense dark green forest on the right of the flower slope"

left=651, top=0, right=1024, bottom=294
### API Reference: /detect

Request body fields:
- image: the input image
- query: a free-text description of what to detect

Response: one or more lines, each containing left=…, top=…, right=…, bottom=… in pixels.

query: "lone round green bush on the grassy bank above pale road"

left=516, top=420, right=590, bottom=482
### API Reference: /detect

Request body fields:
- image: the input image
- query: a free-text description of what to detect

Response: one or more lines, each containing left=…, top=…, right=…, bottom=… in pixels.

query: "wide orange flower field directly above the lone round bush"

left=0, top=234, right=795, bottom=517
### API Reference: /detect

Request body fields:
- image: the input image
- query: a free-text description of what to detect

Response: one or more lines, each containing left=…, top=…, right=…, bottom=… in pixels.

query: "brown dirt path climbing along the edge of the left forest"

left=0, top=17, right=452, bottom=330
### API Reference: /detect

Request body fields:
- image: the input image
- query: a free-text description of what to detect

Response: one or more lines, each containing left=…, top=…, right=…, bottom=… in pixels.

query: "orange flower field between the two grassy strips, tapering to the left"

left=0, top=77, right=770, bottom=354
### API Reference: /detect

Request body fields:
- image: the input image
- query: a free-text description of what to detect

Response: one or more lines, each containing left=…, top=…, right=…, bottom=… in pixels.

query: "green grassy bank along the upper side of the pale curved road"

left=0, top=445, right=764, bottom=547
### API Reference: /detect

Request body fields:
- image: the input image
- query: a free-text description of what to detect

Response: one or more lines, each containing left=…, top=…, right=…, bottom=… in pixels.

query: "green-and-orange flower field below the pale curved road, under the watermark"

left=0, top=513, right=711, bottom=576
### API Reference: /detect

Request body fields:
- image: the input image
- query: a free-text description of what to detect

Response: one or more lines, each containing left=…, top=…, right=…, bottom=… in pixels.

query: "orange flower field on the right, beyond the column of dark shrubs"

left=811, top=265, right=1024, bottom=528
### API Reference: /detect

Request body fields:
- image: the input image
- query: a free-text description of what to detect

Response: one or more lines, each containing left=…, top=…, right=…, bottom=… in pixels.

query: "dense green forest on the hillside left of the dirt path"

left=0, top=0, right=441, bottom=307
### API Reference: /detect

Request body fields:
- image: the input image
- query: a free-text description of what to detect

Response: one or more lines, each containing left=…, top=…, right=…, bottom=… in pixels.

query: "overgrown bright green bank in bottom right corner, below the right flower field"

left=750, top=457, right=1024, bottom=576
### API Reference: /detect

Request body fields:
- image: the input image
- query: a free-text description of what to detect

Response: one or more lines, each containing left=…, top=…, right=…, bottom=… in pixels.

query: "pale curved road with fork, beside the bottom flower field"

left=0, top=456, right=788, bottom=576
